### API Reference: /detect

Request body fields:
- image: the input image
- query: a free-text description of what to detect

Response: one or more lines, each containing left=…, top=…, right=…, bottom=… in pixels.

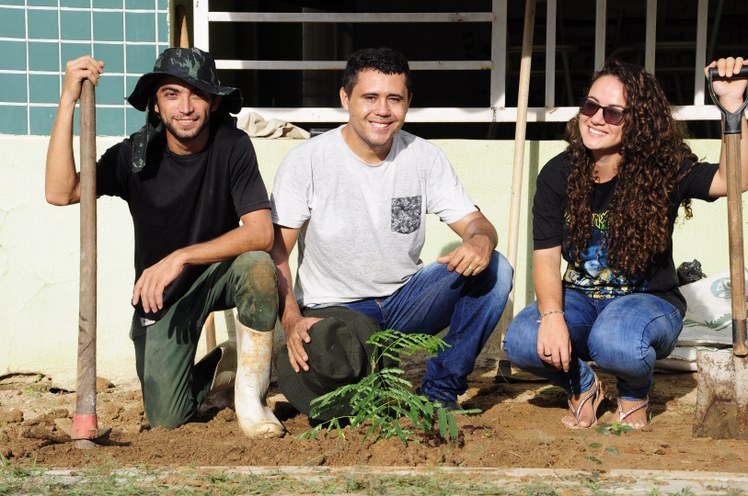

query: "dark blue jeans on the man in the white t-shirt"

left=345, top=252, right=513, bottom=402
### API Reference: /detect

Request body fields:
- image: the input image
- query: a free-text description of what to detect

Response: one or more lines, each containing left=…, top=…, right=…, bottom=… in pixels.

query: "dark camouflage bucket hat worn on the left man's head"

left=127, top=48, right=242, bottom=114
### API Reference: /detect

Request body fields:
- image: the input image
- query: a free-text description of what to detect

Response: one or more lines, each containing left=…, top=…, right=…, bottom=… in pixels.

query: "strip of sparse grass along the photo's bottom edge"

left=0, top=468, right=555, bottom=496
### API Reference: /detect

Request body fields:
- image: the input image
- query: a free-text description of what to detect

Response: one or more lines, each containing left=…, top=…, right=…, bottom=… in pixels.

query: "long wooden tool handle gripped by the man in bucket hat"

left=74, top=79, right=96, bottom=428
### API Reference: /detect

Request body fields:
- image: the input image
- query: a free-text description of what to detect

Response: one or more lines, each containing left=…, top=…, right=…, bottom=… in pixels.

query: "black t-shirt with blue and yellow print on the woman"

left=532, top=152, right=719, bottom=314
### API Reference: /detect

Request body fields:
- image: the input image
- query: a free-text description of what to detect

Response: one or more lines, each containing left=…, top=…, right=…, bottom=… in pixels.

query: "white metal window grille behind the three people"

left=193, top=0, right=722, bottom=123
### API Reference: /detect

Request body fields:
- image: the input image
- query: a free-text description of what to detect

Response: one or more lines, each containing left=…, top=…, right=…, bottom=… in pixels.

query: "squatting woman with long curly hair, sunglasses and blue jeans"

left=504, top=58, right=748, bottom=429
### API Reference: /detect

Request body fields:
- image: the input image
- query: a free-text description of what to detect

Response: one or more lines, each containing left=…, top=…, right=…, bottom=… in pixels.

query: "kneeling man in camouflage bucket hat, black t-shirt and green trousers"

left=45, top=48, right=284, bottom=437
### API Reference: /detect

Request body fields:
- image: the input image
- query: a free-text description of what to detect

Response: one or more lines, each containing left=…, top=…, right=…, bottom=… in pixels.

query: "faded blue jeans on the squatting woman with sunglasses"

left=504, top=289, right=683, bottom=401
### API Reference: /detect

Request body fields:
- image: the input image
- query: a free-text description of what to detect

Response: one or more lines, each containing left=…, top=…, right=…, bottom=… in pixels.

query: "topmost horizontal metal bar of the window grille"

left=207, top=11, right=493, bottom=23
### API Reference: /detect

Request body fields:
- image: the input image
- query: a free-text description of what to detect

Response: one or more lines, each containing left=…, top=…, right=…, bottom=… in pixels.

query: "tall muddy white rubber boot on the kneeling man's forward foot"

left=234, top=319, right=286, bottom=439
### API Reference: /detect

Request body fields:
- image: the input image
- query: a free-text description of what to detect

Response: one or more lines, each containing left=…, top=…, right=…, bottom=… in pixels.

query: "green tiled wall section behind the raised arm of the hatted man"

left=0, top=0, right=169, bottom=136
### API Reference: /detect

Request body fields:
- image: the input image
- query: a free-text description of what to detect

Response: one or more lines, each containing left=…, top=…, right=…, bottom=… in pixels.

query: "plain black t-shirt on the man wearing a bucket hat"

left=96, top=124, right=270, bottom=319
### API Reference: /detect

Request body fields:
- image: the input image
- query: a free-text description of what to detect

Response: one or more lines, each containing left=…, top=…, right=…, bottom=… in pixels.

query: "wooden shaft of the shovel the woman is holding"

left=724, top=134, right=748, bottom=357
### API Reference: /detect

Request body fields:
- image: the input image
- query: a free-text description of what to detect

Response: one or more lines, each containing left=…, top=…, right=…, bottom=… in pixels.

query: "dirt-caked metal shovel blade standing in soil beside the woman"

left=693, top=349, right=748, bottom=439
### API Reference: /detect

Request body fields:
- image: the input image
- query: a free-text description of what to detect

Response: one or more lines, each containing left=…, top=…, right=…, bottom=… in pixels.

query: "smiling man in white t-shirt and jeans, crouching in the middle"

left=271, top=48, right=512, bottom=410
